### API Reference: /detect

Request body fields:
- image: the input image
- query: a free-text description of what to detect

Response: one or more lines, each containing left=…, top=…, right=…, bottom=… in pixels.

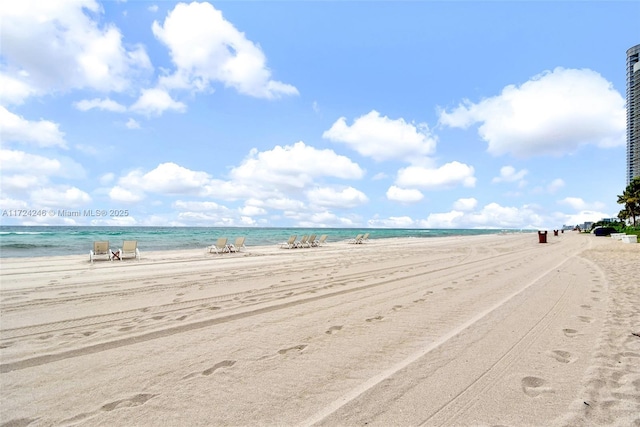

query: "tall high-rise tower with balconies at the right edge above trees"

left=627, top=44, right=640, bottom=184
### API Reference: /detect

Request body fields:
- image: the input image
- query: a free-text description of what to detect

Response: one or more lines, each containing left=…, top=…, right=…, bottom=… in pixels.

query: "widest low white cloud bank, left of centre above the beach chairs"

left=108, top=142, right=368, bottom=219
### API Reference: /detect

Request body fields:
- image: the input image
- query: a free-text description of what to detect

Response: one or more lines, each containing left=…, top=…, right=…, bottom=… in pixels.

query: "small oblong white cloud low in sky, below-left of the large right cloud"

left=396, top=162, right=476, bottom=190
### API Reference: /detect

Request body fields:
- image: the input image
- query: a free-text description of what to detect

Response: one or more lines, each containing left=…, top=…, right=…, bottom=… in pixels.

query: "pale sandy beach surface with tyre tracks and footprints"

left=0, top=232, right=640, bottom=426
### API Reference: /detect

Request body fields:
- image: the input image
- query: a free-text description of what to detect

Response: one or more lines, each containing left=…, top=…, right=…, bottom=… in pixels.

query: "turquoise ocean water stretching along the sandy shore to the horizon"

left=0, top=226, right=522, bottom=258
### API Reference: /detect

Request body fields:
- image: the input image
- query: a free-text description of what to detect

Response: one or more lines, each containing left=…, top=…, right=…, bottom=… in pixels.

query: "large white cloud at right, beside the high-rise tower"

left=440, top=68, right=626, bottom=158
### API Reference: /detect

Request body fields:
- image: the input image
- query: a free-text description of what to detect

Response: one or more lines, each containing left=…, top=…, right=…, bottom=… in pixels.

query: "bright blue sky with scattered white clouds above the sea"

left=0, top=0, right=640, bottom=228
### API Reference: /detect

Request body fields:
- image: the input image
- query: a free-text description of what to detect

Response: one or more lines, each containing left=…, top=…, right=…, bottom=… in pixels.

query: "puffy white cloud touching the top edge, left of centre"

left=152, top=2, right=298, bottom=98
